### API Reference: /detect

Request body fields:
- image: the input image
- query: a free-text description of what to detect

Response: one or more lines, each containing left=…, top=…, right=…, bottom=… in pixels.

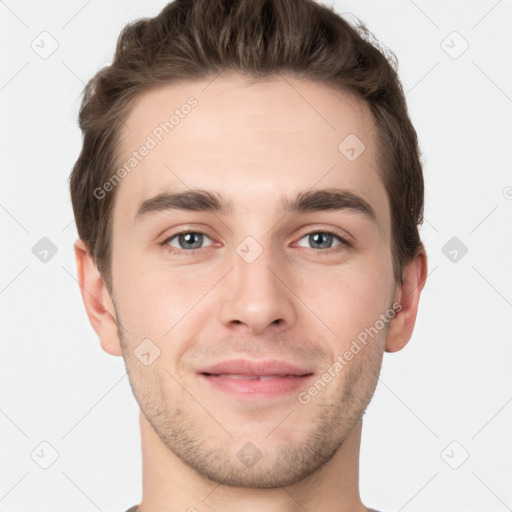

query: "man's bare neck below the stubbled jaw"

left=139, top=412, right=368, bottom=512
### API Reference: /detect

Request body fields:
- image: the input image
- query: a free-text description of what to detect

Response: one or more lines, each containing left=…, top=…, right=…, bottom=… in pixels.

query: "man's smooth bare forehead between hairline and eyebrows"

left=114, top=75, right=388, bottom=226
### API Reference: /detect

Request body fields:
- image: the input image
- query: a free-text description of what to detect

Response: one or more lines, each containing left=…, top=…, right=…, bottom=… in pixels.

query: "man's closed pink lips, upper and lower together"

left=199, top=359, right=314, bottom=398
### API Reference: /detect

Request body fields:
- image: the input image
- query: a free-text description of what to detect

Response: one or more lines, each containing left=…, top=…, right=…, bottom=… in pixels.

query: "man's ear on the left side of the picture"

left=74, top=239, right=122, bottom=356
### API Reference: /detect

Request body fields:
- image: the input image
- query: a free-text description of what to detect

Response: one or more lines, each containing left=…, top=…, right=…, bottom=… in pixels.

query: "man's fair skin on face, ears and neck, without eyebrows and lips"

left=75, top=75, right=427, bottom=512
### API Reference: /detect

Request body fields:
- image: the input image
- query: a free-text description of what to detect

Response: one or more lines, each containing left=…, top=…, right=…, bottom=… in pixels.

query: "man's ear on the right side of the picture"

left=386, top=244, right=428, bottom=352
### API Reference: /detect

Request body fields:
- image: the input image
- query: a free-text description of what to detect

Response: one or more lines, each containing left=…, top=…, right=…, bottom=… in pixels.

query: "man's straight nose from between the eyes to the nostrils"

left=221, top=236, right=295, bottom=334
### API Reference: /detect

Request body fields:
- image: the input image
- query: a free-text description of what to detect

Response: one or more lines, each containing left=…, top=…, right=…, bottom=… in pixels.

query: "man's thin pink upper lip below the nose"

left=199, top=359, right=313, bottom=376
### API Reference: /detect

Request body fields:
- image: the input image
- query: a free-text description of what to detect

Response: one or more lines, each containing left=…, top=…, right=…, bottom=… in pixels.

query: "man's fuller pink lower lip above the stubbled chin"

left=200, top=374, right=313, bottom=398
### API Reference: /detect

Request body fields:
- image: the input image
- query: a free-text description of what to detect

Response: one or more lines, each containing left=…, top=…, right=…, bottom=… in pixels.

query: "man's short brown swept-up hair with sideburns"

left=70, top=0, right=424, bottom=290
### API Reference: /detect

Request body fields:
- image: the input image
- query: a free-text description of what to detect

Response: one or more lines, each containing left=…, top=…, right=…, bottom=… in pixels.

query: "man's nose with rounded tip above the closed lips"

left=220, top=240, right=297, bottom=335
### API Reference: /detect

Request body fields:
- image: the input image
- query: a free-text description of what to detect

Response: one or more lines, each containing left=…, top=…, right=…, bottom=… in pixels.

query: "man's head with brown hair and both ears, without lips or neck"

left=70, top=0, right=426, bottom=487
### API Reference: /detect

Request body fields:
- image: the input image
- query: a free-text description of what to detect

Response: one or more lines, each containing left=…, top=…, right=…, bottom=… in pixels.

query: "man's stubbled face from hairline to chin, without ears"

left=112, top=76, right=397, bottom=487
